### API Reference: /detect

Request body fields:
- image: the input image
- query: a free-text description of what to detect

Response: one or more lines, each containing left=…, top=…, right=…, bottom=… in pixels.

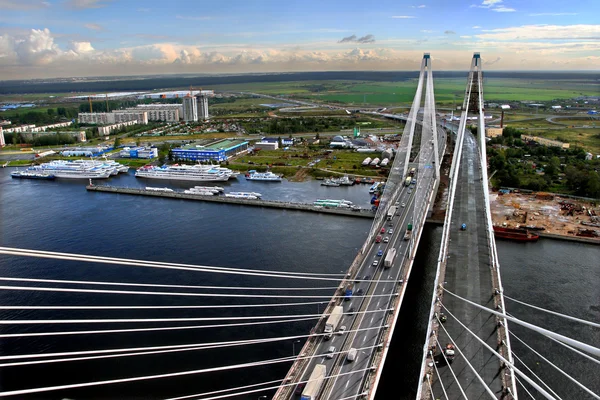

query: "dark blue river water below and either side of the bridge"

left=0, top=168, right=600, bottom=399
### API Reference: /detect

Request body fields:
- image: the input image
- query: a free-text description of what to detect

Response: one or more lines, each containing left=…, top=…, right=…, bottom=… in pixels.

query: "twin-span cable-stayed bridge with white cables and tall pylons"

left=0, top=54, right=598, bottom=399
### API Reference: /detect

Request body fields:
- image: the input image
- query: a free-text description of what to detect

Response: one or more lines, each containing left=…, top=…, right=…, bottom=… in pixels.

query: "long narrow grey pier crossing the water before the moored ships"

left=85, top=185, right=375, bottom=218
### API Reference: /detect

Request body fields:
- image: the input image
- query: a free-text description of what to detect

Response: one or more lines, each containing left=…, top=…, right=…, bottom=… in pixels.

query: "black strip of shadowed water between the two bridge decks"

left=375, top=224, right=442, bottom=400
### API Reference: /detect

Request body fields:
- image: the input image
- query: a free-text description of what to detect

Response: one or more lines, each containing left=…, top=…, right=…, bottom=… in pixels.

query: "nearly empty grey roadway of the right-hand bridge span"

left=433, top=133, right=502, bottom=399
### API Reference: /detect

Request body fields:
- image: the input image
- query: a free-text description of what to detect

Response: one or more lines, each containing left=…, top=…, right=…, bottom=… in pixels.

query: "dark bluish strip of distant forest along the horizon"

left=0, top=71, right=593, bottom=94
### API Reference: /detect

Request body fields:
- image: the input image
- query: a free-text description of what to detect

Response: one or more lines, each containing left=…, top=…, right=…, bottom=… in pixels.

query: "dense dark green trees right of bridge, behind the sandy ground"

left=488, top=128, right=600, bottom=198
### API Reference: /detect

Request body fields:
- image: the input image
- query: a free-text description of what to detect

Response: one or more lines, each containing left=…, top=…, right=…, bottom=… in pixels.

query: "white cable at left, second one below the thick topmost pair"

left=0, top=280, right=397, bottom=301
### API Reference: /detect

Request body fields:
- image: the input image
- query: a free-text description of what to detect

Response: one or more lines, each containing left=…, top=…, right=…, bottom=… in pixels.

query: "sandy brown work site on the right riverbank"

left=490, top=191, right=600, bottom=244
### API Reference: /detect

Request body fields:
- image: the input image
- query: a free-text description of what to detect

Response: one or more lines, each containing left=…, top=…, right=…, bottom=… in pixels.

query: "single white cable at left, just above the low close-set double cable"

left=0, top=317, right=320, bottom=338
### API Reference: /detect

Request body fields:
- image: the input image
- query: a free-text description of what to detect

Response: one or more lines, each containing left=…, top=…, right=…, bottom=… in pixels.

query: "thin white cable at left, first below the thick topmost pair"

left=0, top=277, right=338, bottom=291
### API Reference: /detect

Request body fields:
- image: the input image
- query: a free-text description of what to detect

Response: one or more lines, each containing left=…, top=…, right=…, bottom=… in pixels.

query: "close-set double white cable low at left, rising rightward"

left=0, top=326, right=382, bottom=367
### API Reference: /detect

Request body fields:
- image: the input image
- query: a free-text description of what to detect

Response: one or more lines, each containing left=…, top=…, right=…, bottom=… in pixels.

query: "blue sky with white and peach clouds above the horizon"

left=0, top=0, right=600, bottom=80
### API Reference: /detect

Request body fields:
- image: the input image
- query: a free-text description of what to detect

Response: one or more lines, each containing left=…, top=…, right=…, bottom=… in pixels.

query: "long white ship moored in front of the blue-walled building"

left=135, top=164, right=233, bottom=182
